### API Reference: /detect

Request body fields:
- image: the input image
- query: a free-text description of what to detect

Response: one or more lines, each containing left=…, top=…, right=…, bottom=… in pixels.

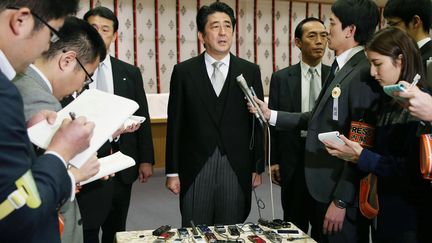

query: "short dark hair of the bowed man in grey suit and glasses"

left=42, top=17, right=106, bottom=68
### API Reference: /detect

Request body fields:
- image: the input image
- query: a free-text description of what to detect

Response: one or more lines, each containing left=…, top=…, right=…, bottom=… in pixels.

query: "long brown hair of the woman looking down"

left=365, top=27, right=425, bottom=86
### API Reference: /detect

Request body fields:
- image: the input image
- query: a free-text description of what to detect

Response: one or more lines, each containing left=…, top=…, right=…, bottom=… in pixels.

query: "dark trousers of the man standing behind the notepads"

left=84, top=177, right=132, bottom=243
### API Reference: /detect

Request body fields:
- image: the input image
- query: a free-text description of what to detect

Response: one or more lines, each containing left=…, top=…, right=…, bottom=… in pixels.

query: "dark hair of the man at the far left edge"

left=0, top=0, right=79, bottom=30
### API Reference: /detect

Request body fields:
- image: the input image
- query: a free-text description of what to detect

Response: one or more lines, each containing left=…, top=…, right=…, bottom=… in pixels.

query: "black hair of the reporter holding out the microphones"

left=331, top=0, right=380, bottom=45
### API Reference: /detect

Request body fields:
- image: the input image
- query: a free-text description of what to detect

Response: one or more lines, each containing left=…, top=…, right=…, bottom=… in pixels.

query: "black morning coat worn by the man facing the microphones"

left=166, top=54, right=263, bottom=218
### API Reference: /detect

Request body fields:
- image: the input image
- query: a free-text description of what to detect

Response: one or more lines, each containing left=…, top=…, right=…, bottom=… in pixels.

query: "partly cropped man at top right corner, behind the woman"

left=383, top=0, right=432, bottom=88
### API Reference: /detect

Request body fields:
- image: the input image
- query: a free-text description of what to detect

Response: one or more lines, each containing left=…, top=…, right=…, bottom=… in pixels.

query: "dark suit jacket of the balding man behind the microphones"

left=269, top=63, right=330, bottom=185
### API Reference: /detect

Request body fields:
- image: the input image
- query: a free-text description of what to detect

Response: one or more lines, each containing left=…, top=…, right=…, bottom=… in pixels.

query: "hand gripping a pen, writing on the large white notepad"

left=47, top=117, right=95, bottom=162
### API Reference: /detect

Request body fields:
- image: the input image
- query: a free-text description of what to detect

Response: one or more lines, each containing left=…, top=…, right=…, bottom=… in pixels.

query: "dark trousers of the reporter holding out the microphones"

left=312, top=200, right=369, bottom=243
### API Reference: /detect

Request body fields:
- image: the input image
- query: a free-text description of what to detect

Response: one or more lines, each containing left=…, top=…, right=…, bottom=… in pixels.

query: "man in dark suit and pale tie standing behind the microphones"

left=269, top=17, right=330, bottom=237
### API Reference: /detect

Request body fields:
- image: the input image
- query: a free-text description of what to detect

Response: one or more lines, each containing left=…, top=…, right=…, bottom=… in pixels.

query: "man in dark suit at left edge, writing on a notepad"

left=0, top=0, right=98, bottom=242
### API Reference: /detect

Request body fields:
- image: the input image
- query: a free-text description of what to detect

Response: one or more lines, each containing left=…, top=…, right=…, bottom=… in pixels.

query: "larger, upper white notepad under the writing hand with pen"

left=28, top=89, right=139, bottom=168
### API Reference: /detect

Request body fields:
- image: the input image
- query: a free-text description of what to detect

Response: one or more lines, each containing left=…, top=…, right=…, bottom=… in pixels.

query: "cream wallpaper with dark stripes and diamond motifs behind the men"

left=78, top=0, right=372, bottom=94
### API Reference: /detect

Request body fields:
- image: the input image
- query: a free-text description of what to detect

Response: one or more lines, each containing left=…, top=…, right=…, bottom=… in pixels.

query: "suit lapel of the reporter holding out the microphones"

left=312, top=51, right=364, bottom=115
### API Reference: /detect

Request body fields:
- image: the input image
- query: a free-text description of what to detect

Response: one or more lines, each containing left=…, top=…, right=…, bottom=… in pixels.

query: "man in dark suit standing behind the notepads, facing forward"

left=78, top=7, right=154, bottom=243
